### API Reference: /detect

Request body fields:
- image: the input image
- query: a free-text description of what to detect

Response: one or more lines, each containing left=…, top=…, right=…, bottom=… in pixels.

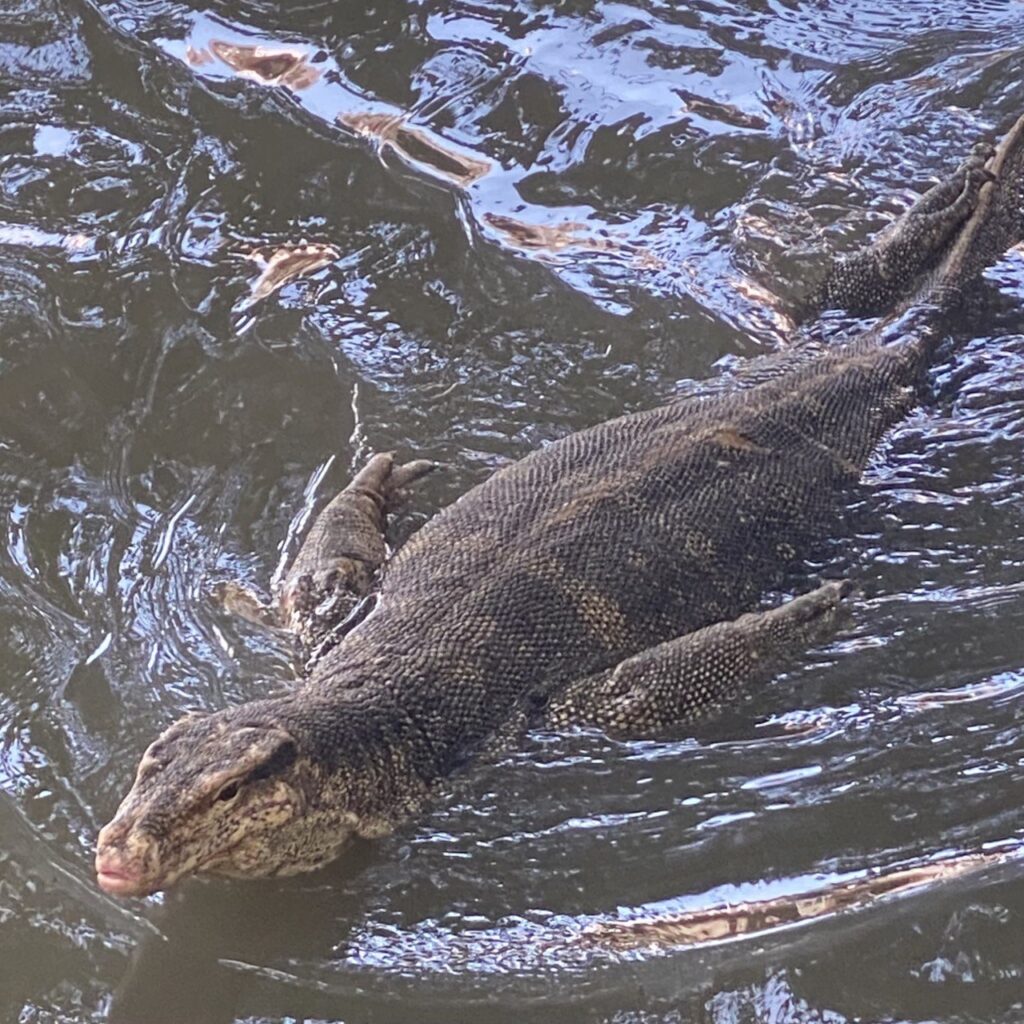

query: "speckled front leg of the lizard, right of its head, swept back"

left=546, top=582, right=852, bottom=734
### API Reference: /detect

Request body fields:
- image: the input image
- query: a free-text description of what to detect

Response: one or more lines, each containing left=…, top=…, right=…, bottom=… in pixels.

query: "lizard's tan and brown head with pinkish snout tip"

left=96, top=698, right=355, bottom=896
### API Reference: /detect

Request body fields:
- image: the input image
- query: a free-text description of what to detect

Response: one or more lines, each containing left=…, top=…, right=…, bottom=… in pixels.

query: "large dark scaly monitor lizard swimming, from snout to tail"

left=96, top=114, right=1024, bottom=895
